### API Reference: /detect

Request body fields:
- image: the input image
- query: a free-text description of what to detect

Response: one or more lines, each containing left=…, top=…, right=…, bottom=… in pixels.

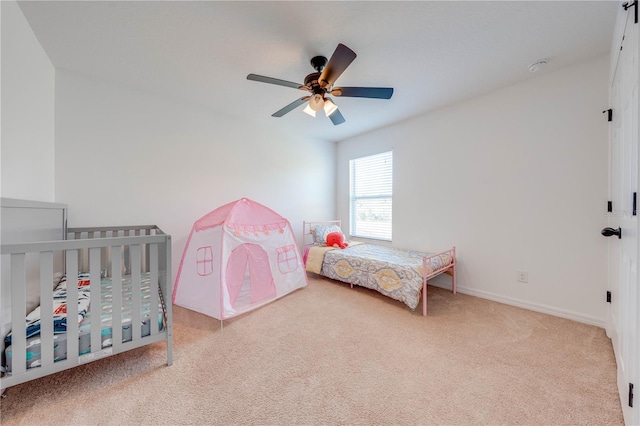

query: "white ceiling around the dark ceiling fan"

left=19, top=1, right=619, bottom=141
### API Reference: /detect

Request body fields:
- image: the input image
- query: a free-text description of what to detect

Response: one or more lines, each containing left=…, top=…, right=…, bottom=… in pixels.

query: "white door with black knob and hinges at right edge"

left=607, top=8, right=640, bottom=425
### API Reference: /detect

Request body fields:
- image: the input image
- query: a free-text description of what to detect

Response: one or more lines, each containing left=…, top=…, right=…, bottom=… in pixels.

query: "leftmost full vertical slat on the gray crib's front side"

left=11, top=253, right=27, bottom=374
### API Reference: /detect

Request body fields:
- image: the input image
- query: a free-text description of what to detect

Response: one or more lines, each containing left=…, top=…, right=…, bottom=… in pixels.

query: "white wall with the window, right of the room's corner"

left=337, top=56, right=609, bottom=326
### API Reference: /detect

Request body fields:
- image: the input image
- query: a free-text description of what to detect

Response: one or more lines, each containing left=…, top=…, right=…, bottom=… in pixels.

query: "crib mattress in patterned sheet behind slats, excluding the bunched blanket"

left=5, top=273, right=163, bottom=372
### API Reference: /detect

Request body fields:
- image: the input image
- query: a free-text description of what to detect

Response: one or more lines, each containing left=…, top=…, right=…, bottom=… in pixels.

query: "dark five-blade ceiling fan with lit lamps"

left=247, top=44, right=393, bottom=126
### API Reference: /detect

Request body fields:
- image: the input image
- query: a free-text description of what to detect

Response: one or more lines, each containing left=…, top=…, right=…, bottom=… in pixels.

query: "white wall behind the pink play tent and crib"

left=56, top=70, right=335, bottom=276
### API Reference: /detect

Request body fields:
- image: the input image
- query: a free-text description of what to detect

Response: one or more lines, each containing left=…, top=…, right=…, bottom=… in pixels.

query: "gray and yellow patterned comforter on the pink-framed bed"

left=311, top=244, right=453, bottom=310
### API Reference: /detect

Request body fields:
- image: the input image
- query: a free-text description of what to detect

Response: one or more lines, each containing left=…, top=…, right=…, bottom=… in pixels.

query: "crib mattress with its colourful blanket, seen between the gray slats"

left=4, top=273, right=164, bottom=372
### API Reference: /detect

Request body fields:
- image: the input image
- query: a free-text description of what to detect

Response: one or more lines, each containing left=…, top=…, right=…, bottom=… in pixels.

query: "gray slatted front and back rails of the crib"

left=0, top=226, right=172, bottom=389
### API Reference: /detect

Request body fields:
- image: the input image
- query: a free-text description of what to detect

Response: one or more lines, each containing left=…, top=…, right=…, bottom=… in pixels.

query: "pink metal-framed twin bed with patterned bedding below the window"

left=302, top=220, right=456, bottom=316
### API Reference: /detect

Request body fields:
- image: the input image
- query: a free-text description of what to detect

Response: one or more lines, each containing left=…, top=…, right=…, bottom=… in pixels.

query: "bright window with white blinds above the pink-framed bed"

left=349, top=151, right=393, bottom=241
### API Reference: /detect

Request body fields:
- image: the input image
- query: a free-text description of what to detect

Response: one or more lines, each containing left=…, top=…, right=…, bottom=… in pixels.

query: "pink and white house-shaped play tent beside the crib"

left=173, top=198, right=307, bottom=320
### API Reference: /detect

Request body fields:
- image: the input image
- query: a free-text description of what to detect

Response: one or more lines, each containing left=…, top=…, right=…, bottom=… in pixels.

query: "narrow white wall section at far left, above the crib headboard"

left=0, top=1, right=55, bottom=201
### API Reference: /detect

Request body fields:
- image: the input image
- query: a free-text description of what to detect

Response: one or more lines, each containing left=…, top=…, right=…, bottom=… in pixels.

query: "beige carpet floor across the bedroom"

left=0, top=277, right=623, bottom=425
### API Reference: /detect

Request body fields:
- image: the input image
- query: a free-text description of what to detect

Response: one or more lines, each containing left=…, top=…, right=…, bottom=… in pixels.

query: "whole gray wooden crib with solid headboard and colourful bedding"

left=0, top=198, right=172, bottom=391
